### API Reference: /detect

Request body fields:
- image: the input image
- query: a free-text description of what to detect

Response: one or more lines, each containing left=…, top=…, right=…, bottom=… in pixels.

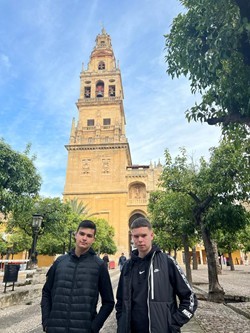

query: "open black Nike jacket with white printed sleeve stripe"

left=116, top=246, right=197, bottom=333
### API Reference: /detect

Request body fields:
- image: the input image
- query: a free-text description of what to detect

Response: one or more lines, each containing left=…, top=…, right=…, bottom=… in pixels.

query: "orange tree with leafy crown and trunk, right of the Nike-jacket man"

left=162, top=139, right=250, bottom=302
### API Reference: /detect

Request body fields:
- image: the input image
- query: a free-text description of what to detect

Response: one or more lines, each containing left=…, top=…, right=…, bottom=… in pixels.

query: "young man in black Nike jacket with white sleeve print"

left=116, top=217, right=197, bottom=333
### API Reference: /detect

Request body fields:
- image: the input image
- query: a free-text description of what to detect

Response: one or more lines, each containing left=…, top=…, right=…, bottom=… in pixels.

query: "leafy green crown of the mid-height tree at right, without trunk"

left=161, top=137, right=250, bottom=252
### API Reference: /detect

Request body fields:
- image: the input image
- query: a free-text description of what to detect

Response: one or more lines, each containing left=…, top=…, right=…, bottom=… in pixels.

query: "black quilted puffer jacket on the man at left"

left=41, top=249, right=114, bottom=333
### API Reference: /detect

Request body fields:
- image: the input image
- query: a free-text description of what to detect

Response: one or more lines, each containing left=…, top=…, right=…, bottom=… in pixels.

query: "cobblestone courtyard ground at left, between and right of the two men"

left=0, top=266, right=250, bottom=333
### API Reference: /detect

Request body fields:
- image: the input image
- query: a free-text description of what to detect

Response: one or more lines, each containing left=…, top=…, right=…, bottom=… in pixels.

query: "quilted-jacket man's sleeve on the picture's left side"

left=41, top=263, right=55, bottom=332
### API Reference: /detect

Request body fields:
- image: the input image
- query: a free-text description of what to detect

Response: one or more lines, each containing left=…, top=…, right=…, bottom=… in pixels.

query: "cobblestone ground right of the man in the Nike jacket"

left=192, top=265, right=250, bottom=333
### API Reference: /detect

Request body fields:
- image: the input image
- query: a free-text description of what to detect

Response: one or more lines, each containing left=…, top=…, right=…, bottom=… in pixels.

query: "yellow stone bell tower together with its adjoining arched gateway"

left=63, top=29, right=162, bottom=255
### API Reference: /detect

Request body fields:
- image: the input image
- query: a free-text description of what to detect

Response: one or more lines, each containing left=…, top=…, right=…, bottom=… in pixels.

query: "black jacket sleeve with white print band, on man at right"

left=168, top=257, right=197, bottom=327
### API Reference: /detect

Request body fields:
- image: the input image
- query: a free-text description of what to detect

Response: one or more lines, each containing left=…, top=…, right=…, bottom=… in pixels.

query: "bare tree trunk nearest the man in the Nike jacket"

left=199, top=217, right=225, bottom=303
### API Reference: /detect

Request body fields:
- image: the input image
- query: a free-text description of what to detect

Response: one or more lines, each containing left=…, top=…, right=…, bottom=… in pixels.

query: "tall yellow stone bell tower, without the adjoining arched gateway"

left=63, top=29, right=132, bottom=231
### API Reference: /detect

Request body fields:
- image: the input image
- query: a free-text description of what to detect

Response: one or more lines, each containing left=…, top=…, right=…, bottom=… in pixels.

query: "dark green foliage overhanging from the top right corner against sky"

left=165, top=0, right=250, bottom=132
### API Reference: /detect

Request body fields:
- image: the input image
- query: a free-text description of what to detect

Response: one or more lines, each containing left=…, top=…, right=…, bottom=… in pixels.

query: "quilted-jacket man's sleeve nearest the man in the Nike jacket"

left=91, top=264, right=115, bottom=333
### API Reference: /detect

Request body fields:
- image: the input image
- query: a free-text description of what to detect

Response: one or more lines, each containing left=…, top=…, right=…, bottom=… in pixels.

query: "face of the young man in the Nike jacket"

left=131, top=227, right=154, bottom=258
